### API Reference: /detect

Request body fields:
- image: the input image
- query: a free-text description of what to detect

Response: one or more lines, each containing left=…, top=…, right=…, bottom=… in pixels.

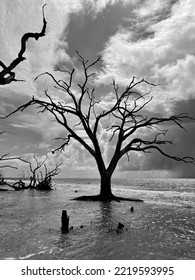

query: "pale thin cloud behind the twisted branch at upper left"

left=0, top=0, right=82, bottom=95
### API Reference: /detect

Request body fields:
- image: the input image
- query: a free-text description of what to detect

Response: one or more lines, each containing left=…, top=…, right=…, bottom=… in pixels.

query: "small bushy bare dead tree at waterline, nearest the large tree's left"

left=20, top=155, right=61, bottom=190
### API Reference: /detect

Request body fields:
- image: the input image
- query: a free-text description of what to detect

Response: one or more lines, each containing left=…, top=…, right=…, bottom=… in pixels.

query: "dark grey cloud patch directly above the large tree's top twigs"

left=66, top=2, right=136, bottom=59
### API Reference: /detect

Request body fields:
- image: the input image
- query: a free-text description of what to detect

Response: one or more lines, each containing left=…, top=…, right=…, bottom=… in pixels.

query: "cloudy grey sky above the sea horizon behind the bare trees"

left=0, top=0, right=195, bottom=177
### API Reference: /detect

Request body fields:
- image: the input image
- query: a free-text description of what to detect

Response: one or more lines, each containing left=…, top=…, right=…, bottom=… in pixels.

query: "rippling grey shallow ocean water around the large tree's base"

left=0, top=179, right=195, bottom=260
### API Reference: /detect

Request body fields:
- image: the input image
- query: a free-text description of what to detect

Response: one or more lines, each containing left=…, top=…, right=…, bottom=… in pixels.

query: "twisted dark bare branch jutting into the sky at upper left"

left=0, top=4, right=47, bottom=85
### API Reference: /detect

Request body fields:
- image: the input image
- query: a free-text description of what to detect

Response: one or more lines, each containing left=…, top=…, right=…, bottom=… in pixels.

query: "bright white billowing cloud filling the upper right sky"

left=97, top=0, right=195, bottom=109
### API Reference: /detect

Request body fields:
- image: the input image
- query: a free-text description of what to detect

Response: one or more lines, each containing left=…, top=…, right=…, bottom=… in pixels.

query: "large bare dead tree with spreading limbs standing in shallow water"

left=4, top=52, right=195, bottom=201
